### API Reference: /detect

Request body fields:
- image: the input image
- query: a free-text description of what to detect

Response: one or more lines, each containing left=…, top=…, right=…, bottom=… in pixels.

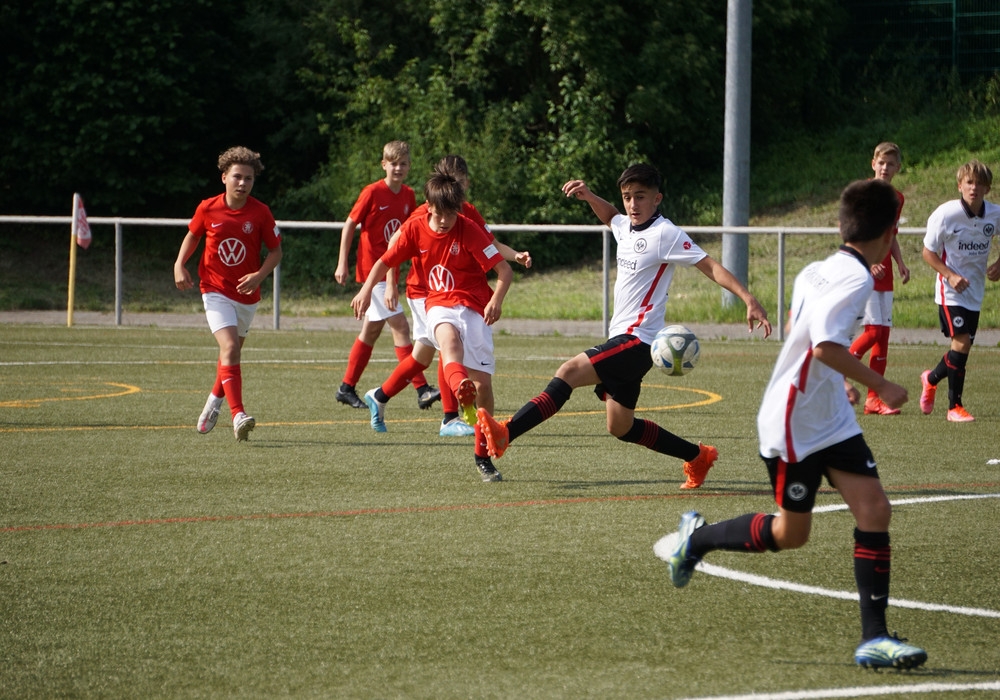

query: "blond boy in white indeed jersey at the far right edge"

left=920, top=160, right=1000, bottom=423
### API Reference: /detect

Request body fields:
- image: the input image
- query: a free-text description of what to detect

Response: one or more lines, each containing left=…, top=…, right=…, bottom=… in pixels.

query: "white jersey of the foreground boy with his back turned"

left=757, top=248, right=874, bottom=463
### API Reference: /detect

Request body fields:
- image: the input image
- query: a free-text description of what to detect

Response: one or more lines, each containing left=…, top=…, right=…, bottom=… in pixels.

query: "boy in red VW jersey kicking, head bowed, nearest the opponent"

left=351, top=173, right=514, bottom=481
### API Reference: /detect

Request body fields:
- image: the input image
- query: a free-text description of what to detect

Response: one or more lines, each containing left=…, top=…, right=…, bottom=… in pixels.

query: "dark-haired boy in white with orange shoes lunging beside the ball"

left=477, top=164, right=771, bottom=489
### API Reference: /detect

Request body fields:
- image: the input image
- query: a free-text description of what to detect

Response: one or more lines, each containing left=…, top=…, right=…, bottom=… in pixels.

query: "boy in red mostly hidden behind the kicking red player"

left=364, top=155, right=531, bottom=437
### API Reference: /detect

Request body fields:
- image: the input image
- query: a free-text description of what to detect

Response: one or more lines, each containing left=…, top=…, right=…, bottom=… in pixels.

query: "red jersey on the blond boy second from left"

left=350, top=180, right=417, bottom=283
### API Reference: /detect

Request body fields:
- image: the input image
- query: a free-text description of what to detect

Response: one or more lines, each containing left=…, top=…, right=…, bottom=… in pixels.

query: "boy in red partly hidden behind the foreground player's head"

left=847, top=141, right=910, bottom=416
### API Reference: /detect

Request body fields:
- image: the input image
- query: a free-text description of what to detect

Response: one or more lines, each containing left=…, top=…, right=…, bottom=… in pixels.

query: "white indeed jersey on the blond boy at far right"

left=924, top=199, right=1000, bottom=311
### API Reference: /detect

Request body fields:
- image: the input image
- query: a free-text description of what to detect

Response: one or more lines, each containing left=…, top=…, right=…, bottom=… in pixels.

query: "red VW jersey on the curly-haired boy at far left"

left=188, top=194, right=281, bottom=304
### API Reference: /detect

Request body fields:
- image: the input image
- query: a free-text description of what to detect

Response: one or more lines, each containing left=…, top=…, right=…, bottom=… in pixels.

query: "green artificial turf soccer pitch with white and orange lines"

left=0, top=325, right=1000, bottom=699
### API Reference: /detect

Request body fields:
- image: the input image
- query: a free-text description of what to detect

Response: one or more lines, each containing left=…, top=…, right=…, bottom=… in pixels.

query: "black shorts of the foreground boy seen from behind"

left=761, top=433, right=878, bottom=513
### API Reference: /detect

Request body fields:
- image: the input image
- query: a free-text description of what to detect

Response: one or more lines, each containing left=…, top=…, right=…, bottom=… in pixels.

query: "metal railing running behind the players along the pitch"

left=0, top=216, right=925, bottom=340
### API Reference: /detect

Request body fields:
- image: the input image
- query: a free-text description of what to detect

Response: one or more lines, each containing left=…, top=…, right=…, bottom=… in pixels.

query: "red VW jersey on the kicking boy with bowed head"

left=382, top=212, right=503, bottom=314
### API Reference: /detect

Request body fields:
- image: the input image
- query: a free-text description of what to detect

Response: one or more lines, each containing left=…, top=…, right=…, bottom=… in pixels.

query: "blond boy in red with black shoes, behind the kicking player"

left=334, top=141, right=440, bottom=416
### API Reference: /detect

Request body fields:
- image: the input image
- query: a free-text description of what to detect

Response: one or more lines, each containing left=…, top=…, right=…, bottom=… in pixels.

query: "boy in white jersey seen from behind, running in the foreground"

left=653, top=179, right=927, bottom=668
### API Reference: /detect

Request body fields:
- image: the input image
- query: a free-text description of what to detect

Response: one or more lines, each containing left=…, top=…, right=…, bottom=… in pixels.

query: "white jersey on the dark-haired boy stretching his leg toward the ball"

left=608, top=214, right=706, bottom=344
